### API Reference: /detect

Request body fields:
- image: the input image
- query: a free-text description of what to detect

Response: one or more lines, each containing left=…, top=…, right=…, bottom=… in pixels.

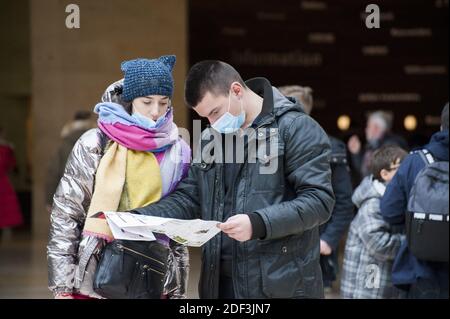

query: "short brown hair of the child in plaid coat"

left=370, top=145, right=408, bottom=182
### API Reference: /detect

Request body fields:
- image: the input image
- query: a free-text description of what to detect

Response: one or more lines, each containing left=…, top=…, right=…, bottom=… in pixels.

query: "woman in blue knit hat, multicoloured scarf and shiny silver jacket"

left=47, top=55, right=191, bottom=298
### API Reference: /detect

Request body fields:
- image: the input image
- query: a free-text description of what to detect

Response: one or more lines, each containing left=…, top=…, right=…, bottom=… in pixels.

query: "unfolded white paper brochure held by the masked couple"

left=105, top=212, right=220, bottom=247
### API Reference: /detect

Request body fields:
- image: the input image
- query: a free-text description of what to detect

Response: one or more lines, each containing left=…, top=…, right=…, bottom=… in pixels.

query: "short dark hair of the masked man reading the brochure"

left=184, top=60, right=246, bottom=108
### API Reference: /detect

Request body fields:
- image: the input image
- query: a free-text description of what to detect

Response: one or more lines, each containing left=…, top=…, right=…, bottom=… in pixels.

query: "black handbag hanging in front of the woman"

left=94, top=240, right=170, bottom=299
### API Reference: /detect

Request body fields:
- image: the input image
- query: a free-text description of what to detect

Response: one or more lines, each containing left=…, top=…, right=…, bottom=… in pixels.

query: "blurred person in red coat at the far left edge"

left=0, top=127, right=23, bottom=240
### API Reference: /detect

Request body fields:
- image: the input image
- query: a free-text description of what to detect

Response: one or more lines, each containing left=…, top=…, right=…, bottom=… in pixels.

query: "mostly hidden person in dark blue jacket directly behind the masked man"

left=279, top=85, right=354, bottom=292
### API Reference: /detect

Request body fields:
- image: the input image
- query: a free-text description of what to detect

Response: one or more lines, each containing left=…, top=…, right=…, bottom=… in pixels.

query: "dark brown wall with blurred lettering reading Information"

left=189, top=0, right=449, bottom=146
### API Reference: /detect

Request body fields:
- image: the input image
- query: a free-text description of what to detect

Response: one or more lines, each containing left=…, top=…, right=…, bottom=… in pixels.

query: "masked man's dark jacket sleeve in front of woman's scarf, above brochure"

left=131, top=164, right=200, bottom=219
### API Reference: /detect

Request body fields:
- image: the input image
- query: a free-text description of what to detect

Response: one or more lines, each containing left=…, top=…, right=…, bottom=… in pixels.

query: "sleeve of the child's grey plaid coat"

left=358, top=200, right=403, bottom=262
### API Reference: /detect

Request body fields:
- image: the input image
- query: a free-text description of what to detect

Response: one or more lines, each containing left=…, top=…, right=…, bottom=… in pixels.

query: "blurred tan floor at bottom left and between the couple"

left=0, top=233, right=339, bottom=299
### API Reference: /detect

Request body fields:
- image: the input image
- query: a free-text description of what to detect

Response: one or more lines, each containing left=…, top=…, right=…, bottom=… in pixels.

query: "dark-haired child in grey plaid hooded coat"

left=341, top=146, right=407, bottom=299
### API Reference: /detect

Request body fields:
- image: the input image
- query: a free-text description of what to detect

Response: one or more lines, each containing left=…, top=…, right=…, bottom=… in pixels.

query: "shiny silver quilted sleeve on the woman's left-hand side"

left=47, top=130, right=100, bottom=292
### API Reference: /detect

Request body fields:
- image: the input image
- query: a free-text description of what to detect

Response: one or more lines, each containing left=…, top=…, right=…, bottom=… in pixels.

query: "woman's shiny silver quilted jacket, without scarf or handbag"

left=47, top=83, right=189, bottom=299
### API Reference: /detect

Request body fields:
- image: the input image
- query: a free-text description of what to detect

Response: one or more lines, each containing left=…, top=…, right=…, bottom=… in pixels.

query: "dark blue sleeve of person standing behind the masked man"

left=320, top=163, right=354, bottom=251
